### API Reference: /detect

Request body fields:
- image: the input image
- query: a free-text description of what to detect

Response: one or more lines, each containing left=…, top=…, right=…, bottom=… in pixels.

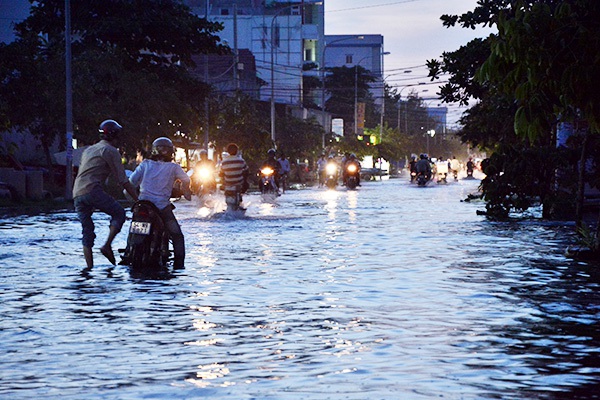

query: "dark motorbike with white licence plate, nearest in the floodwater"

left=119, top=200, right=172, bottom=272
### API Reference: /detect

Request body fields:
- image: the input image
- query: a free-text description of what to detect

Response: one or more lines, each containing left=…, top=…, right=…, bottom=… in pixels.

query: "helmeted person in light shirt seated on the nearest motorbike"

left=129, top=137, right=192, bottom=269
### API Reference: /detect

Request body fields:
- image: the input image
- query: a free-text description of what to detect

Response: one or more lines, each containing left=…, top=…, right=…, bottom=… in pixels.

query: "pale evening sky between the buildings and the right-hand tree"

left=324, top=0, right=493, bottom=126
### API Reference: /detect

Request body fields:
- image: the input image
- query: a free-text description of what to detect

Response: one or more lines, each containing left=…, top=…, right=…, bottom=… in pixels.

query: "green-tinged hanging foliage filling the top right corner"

left=478, top=0, right=600, bottom=141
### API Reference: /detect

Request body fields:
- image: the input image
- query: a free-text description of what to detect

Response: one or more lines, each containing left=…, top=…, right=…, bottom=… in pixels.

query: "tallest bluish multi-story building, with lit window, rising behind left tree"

left=184, top=0, right=324, bottom=105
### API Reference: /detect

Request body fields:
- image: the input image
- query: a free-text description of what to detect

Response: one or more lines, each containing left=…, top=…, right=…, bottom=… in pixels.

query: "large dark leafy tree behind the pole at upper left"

left=0, top=0, right=227, bottom=162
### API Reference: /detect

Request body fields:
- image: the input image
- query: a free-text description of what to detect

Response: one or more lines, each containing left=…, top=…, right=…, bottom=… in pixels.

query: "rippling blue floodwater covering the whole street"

left=0, top=173, right=600, bottom=400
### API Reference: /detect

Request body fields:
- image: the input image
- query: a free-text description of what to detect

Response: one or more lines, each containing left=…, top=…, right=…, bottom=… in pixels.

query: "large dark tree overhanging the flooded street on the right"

left=430, top=0, right=600, bottom=231
